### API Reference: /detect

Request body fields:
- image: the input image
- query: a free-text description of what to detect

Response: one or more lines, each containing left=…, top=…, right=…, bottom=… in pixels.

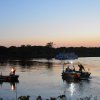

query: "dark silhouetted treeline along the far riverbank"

left=0, top=42, right=100, bottom=60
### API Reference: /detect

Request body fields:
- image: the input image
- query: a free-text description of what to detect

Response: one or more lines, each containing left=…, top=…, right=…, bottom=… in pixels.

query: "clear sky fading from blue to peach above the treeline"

left=0, top=0, right=100, bottom=47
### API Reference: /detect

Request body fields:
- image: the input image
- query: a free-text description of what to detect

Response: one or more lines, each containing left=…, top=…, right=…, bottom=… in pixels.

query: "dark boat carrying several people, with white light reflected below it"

left=62, top=64, right=91, bottom=81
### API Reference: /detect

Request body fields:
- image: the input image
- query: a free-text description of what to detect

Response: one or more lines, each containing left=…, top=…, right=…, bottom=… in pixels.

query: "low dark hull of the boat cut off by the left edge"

left=0, top=75, right=19, bottom=82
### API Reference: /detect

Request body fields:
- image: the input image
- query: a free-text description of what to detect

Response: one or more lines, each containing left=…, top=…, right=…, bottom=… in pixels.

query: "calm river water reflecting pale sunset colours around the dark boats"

left=0, top=57, right=100, bottom=100
